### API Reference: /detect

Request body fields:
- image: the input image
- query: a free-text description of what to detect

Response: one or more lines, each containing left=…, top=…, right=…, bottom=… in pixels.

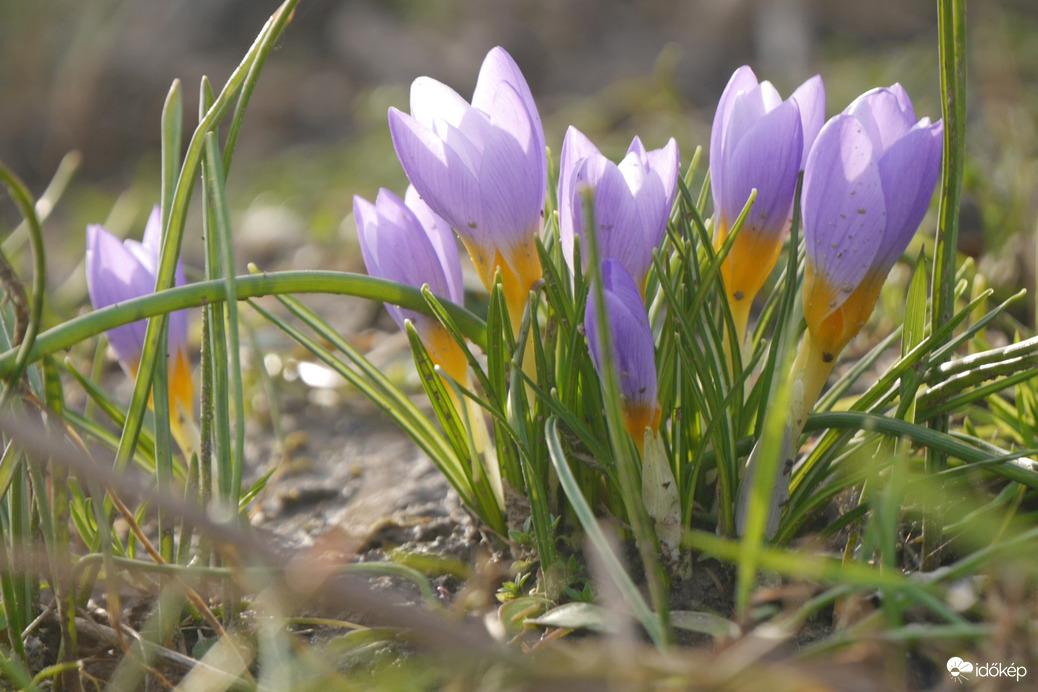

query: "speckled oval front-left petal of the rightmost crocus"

left=801, top=114, right=886, bottom=310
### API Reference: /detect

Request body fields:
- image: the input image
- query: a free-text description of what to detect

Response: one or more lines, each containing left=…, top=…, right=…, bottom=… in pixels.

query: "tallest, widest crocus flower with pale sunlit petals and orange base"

left=389, top=48, right=548, bottom=327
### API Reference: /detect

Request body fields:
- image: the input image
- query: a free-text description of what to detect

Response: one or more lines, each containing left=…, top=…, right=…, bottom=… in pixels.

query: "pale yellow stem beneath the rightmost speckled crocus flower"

left=735, top=331, right=836, bottom=538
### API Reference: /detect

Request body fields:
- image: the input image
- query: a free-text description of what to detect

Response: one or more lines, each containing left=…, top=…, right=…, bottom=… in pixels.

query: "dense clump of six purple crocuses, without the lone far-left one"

left=365, top=48, right=941, bottom=545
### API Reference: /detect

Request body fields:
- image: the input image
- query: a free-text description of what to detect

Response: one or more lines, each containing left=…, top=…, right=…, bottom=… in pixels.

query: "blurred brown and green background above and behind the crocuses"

left=0, top=0, right=1038, bottom=315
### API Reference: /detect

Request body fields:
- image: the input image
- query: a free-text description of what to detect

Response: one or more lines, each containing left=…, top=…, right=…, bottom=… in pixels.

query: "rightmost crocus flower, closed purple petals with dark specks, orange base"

left=801, top=84, right=944, bottom=360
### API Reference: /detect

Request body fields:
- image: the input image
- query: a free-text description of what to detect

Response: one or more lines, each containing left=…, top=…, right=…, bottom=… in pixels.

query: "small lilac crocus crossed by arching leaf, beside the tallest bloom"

left=353, top=187, right=466, bottom=382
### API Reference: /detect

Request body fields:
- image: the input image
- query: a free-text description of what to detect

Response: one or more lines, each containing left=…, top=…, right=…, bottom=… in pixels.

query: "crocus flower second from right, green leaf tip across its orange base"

left=710, top=65, right=825, bottom=340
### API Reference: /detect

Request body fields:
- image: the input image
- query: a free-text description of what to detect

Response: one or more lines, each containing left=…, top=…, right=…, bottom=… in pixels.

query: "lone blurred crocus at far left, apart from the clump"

left=86, top=206, right=194, bottom=414
